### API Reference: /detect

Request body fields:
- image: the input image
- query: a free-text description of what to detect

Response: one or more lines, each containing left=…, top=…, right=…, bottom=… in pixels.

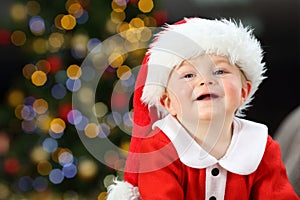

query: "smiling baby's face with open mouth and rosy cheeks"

left=162, top=55, right=251, bottom=124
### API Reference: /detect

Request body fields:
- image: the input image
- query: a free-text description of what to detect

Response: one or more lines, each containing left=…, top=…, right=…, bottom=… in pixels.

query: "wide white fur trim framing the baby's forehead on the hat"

left=141, top=18, right=265, bottom=116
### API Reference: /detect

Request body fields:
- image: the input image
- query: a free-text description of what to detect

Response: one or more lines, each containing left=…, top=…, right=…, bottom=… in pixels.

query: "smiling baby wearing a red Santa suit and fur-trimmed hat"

left=107, top=18, right=299, bottom=200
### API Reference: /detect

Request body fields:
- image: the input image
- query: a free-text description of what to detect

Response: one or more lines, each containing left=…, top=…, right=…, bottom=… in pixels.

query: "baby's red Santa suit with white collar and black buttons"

left=138, top=115, right=299, bottom=200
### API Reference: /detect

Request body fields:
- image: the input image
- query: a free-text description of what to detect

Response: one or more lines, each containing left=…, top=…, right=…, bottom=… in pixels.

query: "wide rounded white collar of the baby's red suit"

left=153, top=115, right=268, bottom=175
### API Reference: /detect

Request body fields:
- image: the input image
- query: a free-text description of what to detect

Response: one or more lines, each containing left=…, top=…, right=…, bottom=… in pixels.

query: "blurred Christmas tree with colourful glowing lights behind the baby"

left=0, top=0, right=166, bottom=200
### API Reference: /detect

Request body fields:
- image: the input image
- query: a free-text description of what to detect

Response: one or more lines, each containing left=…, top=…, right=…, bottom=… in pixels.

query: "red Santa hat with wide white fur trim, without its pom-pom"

left=106, top=18, right=265, bottom=198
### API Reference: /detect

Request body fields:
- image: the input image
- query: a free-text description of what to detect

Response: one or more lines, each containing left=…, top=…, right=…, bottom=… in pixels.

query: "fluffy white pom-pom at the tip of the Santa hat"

left=106, top=180, right=141, bottom=200
